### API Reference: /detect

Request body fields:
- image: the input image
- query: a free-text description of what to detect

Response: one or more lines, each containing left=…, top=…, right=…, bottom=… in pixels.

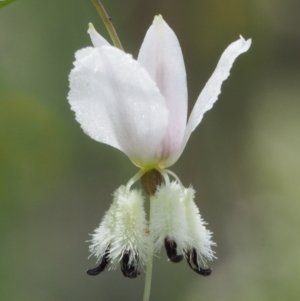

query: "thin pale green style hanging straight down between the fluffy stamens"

left=143, top=196, right=155, bottom=301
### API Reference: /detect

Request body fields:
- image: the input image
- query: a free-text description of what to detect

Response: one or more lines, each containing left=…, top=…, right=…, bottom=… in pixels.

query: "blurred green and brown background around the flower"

left=0, top=0, right=300, bottom=301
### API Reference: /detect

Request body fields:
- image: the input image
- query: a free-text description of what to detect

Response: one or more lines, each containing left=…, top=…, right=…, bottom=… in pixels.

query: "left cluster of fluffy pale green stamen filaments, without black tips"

left=90, top=186, right=149, bottom=268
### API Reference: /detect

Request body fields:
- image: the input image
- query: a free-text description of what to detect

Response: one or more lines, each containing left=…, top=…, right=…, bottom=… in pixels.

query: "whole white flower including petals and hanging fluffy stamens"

left=68, top=15, right=251, bottom=276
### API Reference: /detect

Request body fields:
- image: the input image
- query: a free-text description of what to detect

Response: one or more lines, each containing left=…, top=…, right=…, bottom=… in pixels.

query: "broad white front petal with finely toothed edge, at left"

left=68, top=46, right=168, bottom=167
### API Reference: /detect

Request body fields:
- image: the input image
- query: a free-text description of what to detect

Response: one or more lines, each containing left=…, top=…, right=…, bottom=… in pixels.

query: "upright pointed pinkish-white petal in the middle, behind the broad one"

left=138, top=15, right=187, bottom=157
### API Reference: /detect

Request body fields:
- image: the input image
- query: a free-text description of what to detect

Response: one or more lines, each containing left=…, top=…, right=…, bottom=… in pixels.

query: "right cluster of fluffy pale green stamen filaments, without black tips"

left=150, top=182, right=215, bottom=266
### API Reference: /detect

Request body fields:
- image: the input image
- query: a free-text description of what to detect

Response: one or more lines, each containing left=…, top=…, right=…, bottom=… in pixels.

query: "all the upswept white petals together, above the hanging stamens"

left=68, top=16, right=251, bottom=168
